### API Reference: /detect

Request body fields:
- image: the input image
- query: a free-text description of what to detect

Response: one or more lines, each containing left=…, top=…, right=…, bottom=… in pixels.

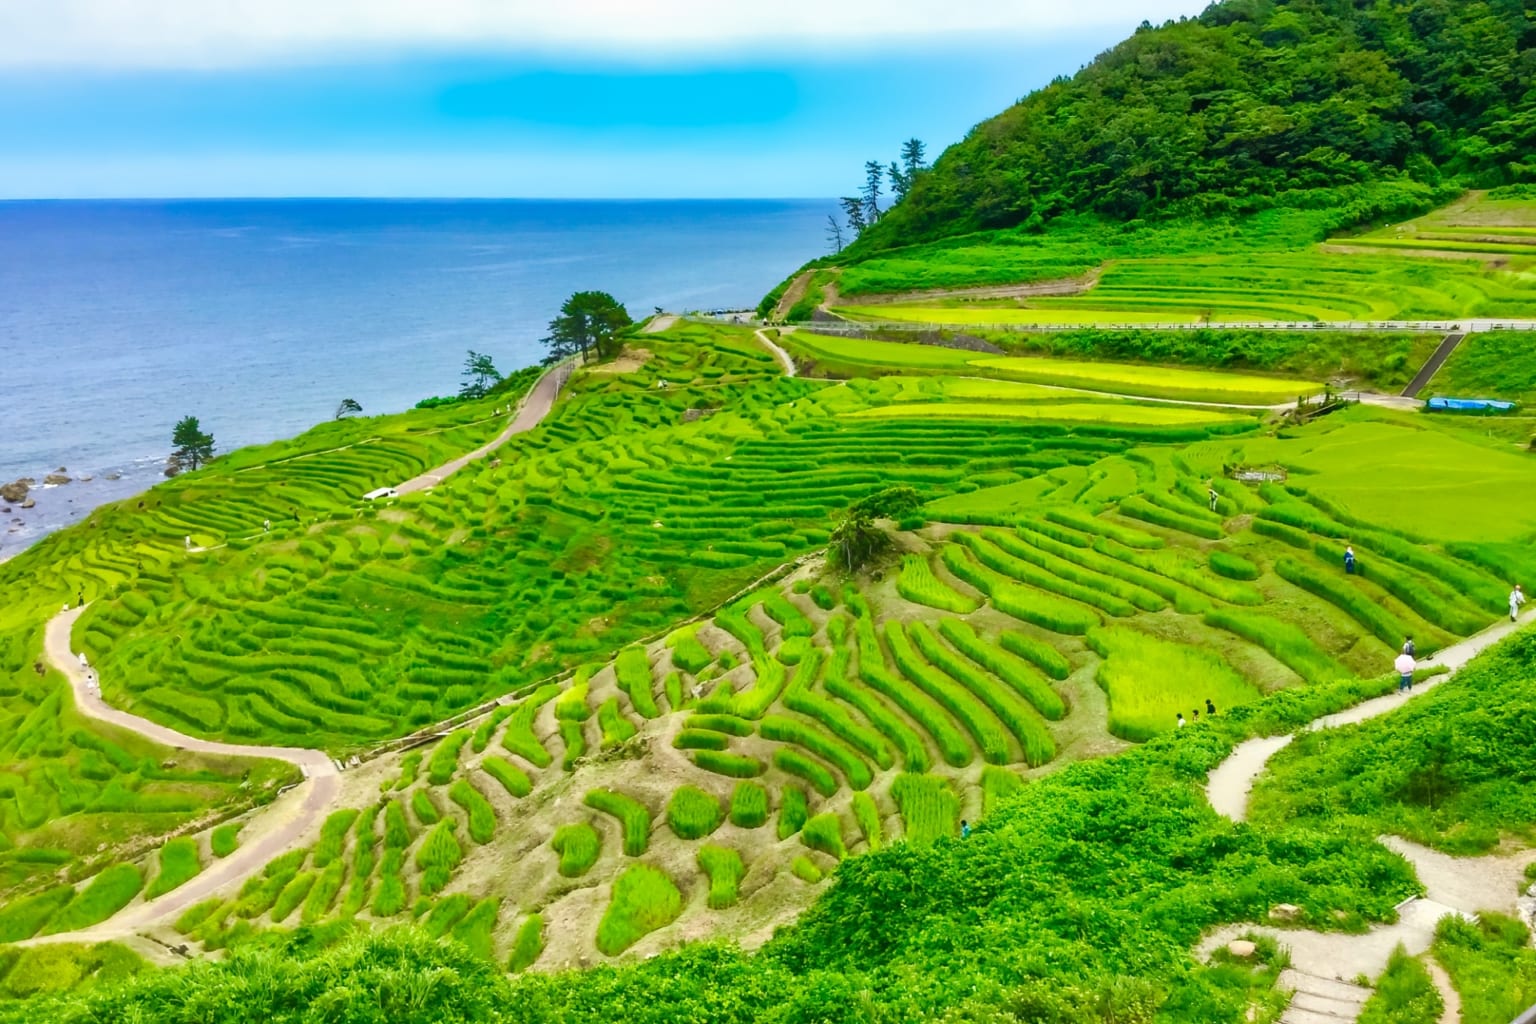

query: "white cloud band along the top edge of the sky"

left=0, top=0, right=1204, bottom=68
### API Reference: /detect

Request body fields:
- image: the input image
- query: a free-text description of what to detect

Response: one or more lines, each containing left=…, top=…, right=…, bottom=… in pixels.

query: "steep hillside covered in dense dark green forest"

left=843, top=0, right=1536, bottom=247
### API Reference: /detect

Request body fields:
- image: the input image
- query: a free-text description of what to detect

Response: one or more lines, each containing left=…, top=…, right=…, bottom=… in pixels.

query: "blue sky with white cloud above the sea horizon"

left=0, top=0, right=1204, bottom=198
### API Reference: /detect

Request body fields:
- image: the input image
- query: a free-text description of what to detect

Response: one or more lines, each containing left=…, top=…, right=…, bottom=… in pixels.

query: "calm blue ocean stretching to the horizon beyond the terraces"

left=0, top=200, right=834, bottom=559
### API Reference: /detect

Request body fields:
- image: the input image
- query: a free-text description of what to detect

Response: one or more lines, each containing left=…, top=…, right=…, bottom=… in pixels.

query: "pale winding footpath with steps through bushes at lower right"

left=1197, top=613, right=1536, bottom=1024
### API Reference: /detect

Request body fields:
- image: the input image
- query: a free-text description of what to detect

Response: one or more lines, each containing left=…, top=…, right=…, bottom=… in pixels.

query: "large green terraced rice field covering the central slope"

left=0, top=320, right=1536, bottom=970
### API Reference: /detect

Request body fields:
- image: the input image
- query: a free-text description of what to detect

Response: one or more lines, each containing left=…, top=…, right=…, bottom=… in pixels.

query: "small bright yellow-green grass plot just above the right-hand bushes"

left=1087, top=626, right=1258, bottom=740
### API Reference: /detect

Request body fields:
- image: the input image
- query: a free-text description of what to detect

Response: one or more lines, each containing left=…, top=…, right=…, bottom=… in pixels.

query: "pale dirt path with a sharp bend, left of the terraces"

left=20, top=605, right=341, bottom=946
